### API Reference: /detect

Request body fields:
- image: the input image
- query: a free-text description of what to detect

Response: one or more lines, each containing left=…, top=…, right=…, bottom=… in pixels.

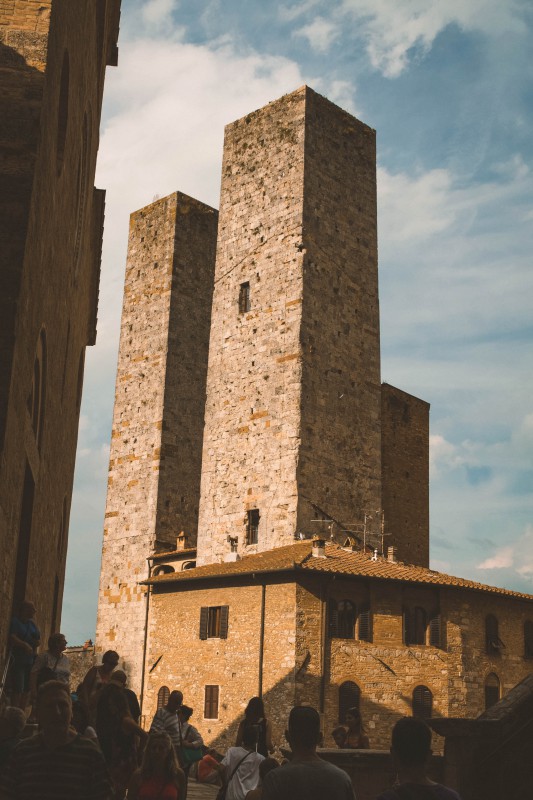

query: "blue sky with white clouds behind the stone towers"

left=62, top=0, right=533, bottom=644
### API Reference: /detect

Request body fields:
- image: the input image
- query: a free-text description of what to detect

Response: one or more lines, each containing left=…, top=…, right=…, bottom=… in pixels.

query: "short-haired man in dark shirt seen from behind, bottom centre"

left=261, top=706, right=355, bottom=800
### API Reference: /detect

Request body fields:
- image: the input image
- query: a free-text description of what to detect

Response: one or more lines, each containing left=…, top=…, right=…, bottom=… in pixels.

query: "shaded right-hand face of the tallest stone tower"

left=297, top=89, right=381, bottom=539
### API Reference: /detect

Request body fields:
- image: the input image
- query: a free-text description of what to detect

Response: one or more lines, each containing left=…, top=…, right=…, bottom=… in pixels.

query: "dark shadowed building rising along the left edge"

left=0, top=0, right=120, bottom=666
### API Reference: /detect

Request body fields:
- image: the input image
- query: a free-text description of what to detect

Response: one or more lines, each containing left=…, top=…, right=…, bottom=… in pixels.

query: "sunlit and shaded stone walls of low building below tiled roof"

left=143, top=575, right=533, bottom=752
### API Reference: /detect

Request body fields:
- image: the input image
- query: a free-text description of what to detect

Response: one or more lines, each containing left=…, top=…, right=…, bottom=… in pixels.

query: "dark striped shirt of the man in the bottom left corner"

left=0, top=733, right=113, bottom=800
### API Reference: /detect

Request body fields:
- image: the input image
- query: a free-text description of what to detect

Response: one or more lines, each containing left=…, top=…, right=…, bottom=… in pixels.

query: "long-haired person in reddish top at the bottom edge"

left=128, top=732, right=185, bottom=800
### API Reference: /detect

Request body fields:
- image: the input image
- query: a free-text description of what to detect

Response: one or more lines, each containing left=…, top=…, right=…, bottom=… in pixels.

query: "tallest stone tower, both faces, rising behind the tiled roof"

left=198, top=87, right=381, bottom=564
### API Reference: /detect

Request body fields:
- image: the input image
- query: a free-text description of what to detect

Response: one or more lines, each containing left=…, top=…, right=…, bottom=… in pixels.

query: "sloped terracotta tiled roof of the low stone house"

left=144, top=540, right=533, bottom=601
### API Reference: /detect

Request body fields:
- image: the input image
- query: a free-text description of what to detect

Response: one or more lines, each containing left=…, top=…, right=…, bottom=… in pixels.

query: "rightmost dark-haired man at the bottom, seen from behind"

left=378, top=717, right=460, bottom=800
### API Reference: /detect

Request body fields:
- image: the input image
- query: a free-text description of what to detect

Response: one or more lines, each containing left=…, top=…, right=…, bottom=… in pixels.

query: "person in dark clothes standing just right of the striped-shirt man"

left=96, top=682, right=148, bottom=800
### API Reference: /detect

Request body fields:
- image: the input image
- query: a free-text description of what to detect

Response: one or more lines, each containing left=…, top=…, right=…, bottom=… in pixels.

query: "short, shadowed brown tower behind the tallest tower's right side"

left=381, top=383, right=429, bottom=567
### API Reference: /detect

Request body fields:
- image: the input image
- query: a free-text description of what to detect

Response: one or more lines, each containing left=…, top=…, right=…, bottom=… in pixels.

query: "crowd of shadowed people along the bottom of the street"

left=0, top=601, right=459, bottom=800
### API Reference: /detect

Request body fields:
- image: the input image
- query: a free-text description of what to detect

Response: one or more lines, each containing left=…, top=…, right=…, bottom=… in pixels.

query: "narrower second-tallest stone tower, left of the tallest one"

left=96, top=193, right=217, bottom=691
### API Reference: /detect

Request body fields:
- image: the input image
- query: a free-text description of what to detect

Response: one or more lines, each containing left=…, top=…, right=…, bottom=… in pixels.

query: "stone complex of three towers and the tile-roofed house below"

left=96, top=87, right=533, bottom=746
